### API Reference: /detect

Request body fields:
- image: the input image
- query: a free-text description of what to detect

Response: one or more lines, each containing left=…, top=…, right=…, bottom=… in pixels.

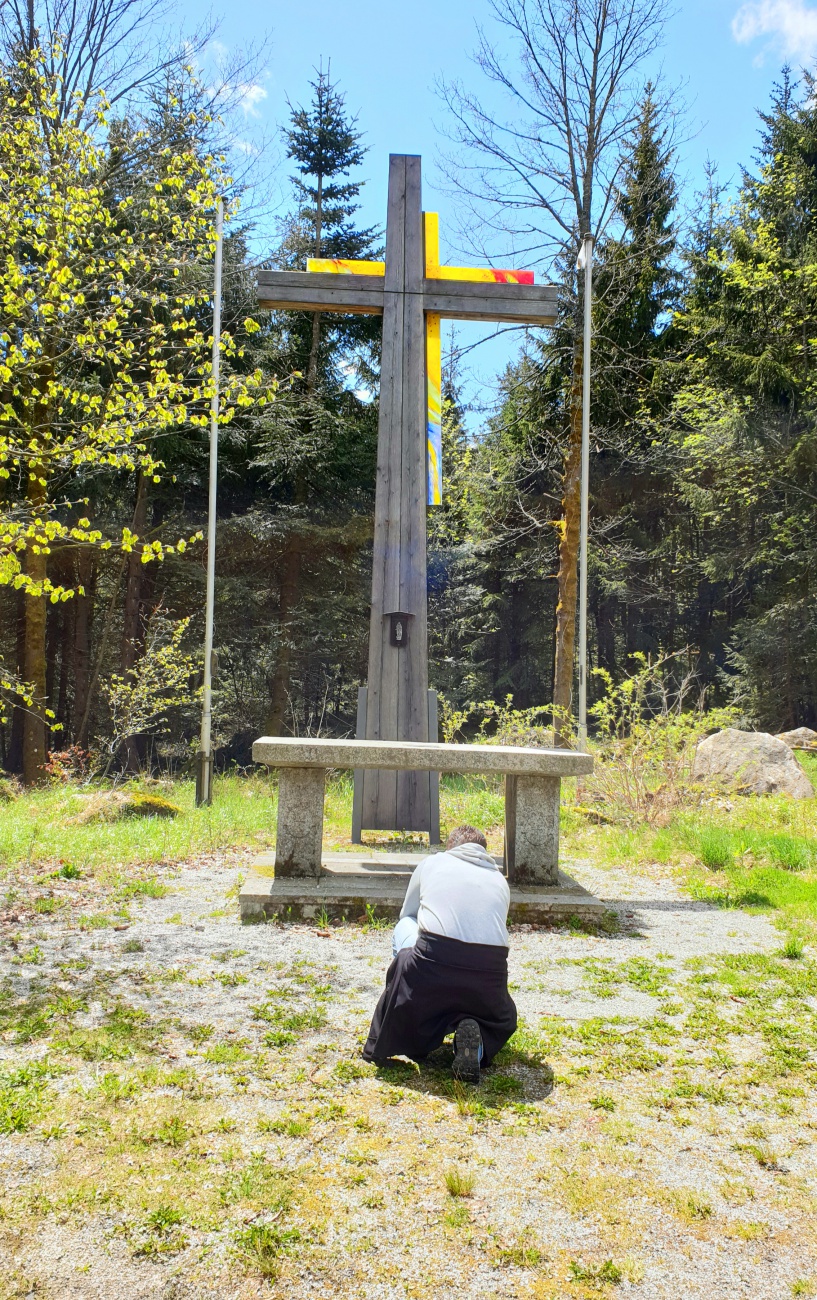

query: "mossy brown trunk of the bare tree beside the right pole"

left=553, top=330, right=583, bottom=749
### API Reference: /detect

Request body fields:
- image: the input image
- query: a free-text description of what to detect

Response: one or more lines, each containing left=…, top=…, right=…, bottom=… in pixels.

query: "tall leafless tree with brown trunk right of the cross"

left=441, top=0, right=669, bottom=744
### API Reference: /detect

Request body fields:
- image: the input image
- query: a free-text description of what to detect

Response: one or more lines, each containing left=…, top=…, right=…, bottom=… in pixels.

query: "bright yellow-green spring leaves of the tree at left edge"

left=0, top=51, right=267, bottom=601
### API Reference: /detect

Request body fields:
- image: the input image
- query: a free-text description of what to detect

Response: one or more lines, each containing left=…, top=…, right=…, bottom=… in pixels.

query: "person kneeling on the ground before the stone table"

left=363, top=826, right=516, bottom=1083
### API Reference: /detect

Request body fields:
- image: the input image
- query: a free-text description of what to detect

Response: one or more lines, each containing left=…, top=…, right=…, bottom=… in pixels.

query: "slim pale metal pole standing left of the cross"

left=195, top=198, right=224, bottom=807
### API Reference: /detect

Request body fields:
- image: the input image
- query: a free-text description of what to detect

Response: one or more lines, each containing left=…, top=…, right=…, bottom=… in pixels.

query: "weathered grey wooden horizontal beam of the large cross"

left=258, top=270, right=557, bottom=326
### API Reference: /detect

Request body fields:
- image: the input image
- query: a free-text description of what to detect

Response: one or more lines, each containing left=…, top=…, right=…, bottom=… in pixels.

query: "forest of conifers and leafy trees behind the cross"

left=0, top=0, right=817, bottom=781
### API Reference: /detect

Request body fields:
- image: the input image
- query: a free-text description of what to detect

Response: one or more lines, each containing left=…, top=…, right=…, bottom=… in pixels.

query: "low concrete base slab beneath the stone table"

left=238, top=853, right=606, bottom=926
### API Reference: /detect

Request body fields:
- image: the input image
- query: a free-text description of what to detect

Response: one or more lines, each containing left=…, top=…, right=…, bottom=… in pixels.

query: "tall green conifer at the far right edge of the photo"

left=673, top=72, right=817, bottom=731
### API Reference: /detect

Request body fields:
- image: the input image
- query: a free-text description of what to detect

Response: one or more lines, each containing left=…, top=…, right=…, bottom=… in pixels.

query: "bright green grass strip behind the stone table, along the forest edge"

left=0, top=755, right=817, bottom=935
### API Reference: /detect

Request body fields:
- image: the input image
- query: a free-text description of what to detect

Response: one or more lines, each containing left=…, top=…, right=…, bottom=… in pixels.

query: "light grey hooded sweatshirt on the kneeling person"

left=401, top=844, right=510, bottom=948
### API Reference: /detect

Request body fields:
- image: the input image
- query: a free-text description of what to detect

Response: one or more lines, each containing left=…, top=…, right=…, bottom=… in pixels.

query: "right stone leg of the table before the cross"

left=505, top=776, right=562, bottom=885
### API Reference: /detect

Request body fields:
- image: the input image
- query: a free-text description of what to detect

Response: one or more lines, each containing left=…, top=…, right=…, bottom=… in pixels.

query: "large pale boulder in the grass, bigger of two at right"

left=692, top=727, right=814, bottom=800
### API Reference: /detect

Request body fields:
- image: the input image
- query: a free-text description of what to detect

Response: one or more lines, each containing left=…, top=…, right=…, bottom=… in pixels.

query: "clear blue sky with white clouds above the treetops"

left=187, top=0, right=817, bottom=410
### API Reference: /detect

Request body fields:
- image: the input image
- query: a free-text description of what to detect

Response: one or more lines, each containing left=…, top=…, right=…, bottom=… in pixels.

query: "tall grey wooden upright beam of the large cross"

left=358, top=155, right=429, bottom=831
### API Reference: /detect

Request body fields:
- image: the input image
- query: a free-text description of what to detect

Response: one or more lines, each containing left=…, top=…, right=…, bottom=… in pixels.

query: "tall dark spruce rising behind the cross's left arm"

left=258, top=69, right=380, bottom=735
